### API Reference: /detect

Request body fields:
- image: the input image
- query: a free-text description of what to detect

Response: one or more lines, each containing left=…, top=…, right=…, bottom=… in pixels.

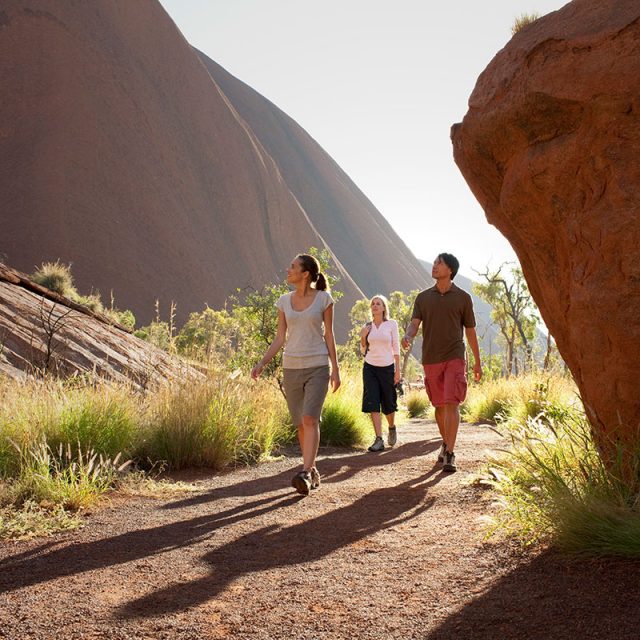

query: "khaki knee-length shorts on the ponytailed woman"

left=283, top=365, right=329, bottom=427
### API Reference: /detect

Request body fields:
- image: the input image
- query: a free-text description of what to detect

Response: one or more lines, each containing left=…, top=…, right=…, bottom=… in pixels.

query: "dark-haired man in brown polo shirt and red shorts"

left=402, top=253, right=482, bottom=471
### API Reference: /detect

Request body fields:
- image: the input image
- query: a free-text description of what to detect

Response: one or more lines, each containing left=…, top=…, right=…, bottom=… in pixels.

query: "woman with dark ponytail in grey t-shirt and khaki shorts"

left=251, top=254, right=340, bottom=495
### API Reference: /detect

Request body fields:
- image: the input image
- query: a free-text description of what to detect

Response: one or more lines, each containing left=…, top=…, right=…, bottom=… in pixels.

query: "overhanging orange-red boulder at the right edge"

left=452, top=0, right=640, bottom=450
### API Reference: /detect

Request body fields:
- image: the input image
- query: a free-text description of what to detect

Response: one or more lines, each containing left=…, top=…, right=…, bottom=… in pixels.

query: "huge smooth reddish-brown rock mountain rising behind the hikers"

left=0, top=0, right=427, bottom=339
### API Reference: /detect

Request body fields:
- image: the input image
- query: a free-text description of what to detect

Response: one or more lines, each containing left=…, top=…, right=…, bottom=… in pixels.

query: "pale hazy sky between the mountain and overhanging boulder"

left=161, top=0, right=566, bottom=276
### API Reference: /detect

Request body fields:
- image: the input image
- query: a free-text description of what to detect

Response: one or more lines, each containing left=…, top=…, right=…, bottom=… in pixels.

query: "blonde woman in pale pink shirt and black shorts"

left=360, top=294, right=400, bottom=452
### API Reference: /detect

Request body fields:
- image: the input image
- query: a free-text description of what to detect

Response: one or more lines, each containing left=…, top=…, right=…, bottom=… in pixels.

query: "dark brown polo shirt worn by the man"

left=412, top=283, right=476, bottom=364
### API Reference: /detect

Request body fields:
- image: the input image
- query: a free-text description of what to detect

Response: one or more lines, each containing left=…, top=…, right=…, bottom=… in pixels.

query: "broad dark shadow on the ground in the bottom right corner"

left=425, top=551, right=640, bottom=640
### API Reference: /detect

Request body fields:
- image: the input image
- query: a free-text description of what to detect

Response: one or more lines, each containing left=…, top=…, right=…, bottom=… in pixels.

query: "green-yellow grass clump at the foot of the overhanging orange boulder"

left=488, top=410, right=640, bottom=558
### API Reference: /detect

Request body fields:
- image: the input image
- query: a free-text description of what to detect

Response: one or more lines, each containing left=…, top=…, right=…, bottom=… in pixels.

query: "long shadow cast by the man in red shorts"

left=119, top=469, right=444, bottom=618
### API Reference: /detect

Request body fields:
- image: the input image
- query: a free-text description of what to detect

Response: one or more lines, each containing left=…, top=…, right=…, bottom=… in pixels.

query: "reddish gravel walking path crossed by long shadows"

left=0, top=421, right=640, bottom=640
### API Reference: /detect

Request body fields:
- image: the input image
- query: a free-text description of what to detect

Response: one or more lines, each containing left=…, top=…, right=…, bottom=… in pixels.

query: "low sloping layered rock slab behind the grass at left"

left=0, top=264, right=201, bottom=388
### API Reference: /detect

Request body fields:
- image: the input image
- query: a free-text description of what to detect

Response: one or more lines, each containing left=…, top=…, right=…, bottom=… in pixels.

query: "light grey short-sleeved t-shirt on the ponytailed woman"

left=276, top=291, right=334, bottom=369
